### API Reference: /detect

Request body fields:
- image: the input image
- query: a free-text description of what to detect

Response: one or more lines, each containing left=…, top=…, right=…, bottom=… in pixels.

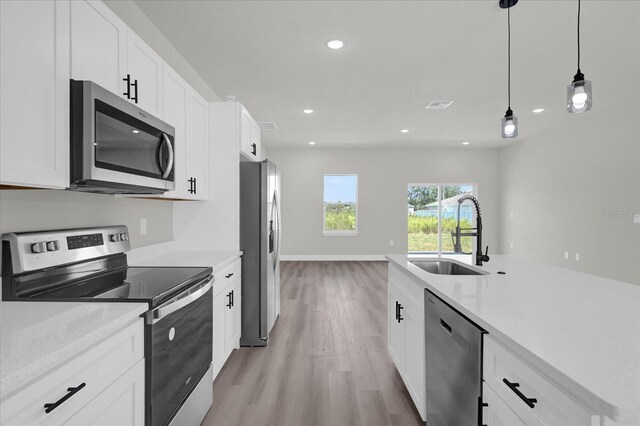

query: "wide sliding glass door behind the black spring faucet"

left=407, top=184, right=476, bottom=254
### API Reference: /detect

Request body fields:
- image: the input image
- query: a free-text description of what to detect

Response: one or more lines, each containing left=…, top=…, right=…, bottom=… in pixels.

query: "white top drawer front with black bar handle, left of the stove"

left=0, top=319, right=144, bottom=426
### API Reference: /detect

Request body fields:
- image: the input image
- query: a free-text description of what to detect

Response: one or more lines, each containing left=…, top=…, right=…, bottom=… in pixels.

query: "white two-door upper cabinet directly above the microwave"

left=71, top=1, right=164, bottom=119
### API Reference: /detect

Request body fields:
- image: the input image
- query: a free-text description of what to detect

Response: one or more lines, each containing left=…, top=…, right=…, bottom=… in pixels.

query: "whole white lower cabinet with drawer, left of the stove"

left=0, top=318, right=145, bottom=426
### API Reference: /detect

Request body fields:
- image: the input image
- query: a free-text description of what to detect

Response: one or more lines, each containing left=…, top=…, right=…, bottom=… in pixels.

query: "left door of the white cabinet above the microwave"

left=71, top=0, right=127, bottom=99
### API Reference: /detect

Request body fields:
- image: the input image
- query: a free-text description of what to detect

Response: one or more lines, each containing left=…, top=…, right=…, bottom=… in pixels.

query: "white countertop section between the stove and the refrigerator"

left=129, top=250, right=242, bottom=273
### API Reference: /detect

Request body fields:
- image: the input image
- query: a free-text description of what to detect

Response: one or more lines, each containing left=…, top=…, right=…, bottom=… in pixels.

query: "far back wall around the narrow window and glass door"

left=269, top=147, right=499, bottom=258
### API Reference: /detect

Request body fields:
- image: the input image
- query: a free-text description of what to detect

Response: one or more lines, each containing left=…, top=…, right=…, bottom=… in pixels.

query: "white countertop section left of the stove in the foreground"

left=0, top=302, right=147, bottom=400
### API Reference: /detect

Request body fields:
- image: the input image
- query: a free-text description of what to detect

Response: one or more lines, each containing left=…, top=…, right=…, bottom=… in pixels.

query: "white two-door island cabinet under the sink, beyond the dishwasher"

left=387, top=265, right=426, bottom=420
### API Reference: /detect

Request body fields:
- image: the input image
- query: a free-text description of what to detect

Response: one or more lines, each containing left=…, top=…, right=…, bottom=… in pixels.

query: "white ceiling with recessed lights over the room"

left=136, top=0, right=640, bottom=149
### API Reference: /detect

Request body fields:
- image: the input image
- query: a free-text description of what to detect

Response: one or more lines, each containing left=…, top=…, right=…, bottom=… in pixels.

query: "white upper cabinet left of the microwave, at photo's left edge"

left=0, top=0, right=69, bottom=188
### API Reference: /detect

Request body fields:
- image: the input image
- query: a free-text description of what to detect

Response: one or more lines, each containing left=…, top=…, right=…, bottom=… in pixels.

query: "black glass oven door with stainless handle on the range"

left=146, top=276, right=213, bottom=426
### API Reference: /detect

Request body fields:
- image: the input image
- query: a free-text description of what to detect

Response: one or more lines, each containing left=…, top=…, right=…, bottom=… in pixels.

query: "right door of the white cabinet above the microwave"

left=123, top=30, right=164, bottom=118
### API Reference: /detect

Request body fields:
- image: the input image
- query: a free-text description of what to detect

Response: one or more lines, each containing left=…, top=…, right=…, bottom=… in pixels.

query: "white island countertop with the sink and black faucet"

left=387, top=254, right=640, bottom=424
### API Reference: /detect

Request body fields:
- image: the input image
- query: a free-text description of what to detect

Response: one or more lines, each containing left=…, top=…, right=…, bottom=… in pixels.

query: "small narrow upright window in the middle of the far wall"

left=323, top=175, right=358, bottom=235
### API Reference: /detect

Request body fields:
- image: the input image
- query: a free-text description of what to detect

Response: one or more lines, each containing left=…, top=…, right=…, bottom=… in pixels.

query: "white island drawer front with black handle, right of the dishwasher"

left=483, top=335, right=600, bottom=426
